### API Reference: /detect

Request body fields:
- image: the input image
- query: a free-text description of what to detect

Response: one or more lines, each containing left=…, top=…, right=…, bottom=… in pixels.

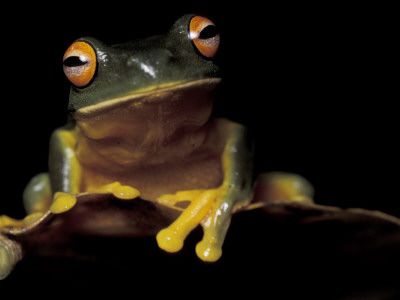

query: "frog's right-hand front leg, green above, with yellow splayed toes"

left=157, top=125, right=253, bottom=261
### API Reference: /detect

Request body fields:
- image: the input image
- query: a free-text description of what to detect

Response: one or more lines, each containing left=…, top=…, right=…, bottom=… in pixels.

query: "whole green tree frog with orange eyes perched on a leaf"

left=0, top=14, right=313, bottom=273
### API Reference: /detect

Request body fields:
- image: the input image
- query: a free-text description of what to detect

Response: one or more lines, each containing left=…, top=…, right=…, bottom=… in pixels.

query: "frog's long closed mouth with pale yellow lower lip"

left=74, top=78, right=221, bottom=119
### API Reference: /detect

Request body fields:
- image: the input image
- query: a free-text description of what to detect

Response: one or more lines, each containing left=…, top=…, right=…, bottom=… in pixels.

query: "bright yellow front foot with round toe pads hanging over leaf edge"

left=157, top=187, right=232, bottom=261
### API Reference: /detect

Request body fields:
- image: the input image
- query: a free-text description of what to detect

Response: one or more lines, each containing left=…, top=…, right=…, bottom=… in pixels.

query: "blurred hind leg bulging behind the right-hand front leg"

left=253, top=172, right=314, bottom=204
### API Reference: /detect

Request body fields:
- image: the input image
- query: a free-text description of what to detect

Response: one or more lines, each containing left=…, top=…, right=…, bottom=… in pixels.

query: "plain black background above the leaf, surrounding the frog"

left=0, top=1, right=400, bottom=298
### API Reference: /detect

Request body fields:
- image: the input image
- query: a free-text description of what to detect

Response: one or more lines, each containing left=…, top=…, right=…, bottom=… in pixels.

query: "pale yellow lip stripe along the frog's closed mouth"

left=74, top=78, right=221, bottom=118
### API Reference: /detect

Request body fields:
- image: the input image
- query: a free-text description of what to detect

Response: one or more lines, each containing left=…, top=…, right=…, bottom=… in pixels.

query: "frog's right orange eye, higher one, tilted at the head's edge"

left=189, top=16, right=220, bottom=58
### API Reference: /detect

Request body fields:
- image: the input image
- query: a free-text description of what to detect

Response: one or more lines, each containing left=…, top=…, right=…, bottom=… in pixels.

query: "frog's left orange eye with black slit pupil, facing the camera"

left=63, top=42, right=96, bottom=87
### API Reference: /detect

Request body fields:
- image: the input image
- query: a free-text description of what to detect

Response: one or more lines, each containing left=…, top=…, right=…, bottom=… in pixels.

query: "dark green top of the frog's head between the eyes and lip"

left=68, top=15, right=221, bottom=112
